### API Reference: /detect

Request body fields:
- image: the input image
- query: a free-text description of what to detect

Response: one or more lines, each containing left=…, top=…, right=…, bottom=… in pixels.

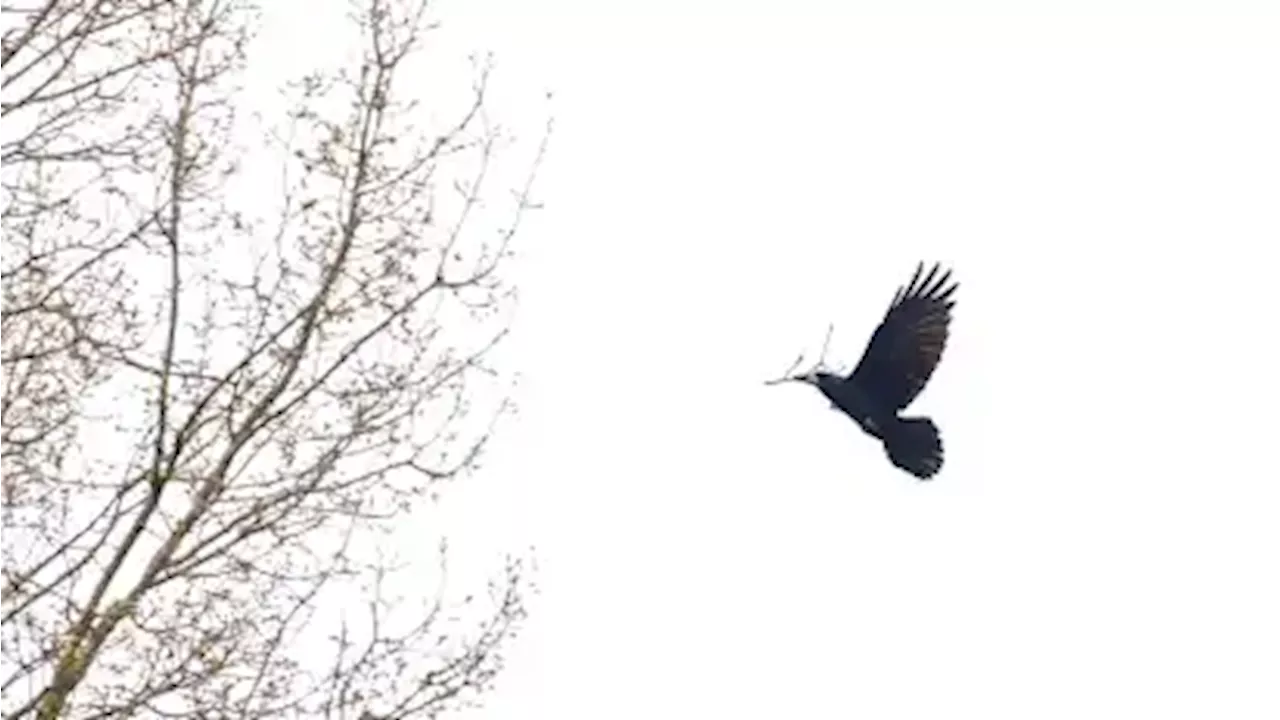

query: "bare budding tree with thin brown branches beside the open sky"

left=0, top=0, right=549, bottom=719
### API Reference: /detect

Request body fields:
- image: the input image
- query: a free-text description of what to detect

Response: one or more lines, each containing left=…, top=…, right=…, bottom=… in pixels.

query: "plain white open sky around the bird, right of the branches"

left=277, top=0, right=1280, bottom=720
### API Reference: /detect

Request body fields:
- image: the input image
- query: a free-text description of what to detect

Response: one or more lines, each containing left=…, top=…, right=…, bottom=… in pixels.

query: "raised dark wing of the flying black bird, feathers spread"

left=849, top=263, right=960, bottom=410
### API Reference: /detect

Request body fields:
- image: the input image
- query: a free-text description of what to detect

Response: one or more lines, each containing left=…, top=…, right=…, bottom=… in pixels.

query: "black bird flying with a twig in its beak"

left=768, top=263, right=960, bottom=480
